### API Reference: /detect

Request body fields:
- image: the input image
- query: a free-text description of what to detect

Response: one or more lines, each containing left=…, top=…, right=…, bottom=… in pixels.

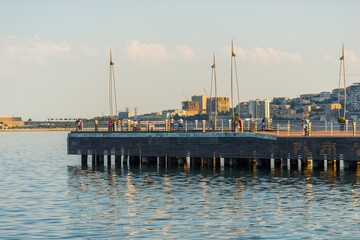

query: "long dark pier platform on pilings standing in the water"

left=68, top=132, right=360, bottom=171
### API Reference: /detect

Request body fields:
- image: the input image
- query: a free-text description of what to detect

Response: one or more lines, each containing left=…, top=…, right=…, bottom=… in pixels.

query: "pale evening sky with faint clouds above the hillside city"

left=0, top=0, right=360, bottom=120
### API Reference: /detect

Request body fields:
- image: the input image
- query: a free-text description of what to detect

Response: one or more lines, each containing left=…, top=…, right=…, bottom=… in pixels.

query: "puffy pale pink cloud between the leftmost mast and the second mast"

left=127, top=40, right=195, bottom=61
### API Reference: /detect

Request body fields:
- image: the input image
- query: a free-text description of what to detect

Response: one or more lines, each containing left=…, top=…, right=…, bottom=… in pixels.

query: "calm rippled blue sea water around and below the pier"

left=0, top=132, right=360, bottom=239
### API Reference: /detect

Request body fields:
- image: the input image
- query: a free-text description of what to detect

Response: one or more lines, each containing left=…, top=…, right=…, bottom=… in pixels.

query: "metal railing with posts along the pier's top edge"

left=77, top=120, right=358, bottom=136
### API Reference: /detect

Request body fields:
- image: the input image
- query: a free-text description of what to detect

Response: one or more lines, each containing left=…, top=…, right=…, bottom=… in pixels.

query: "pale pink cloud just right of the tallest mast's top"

left=231, top=47, right=302, bottom=64
